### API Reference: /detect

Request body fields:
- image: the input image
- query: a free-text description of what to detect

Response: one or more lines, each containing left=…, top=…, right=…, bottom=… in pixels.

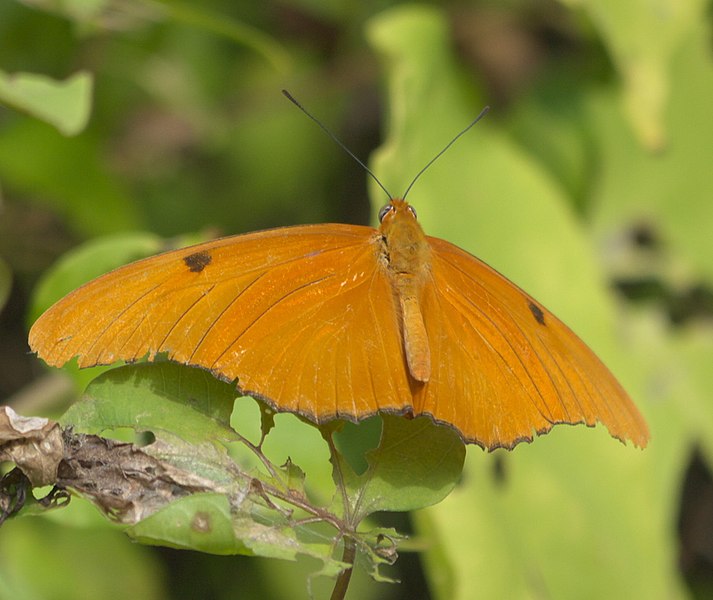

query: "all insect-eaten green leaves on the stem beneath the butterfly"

left=54, top=363, right=465, bottom=575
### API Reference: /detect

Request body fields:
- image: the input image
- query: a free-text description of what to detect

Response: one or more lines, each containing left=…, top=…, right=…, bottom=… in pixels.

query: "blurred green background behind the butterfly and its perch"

left=0, top=0, right=713, bottom=600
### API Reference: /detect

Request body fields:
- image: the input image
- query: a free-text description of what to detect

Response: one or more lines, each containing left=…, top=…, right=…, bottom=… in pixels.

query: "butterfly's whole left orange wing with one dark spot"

left=30, top=225, right=411, bottom=421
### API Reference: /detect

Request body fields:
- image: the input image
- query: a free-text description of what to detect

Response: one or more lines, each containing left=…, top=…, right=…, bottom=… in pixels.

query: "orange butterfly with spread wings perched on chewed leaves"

left=29, top=97, right=648, bottom=449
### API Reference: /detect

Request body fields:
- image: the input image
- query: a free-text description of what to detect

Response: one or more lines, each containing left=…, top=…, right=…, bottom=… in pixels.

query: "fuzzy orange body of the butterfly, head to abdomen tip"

left=380, top=200, right=431, bottom=383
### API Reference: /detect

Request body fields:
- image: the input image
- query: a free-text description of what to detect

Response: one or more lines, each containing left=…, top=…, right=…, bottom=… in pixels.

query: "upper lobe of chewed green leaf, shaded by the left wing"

left=60, top=363, right=251, bottom=494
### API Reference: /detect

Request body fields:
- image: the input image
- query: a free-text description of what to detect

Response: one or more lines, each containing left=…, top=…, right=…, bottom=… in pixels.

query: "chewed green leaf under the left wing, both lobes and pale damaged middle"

left=61, top=363, right=345, bottom=574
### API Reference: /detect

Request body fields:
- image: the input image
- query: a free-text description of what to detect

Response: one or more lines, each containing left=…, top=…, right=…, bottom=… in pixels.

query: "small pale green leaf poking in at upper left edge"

left=0, top=71, right=92, bottom=135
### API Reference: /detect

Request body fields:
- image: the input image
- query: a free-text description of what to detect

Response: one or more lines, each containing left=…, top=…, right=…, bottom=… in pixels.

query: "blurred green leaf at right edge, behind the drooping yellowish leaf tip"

left=589, top=23, right=713, bottom=289
